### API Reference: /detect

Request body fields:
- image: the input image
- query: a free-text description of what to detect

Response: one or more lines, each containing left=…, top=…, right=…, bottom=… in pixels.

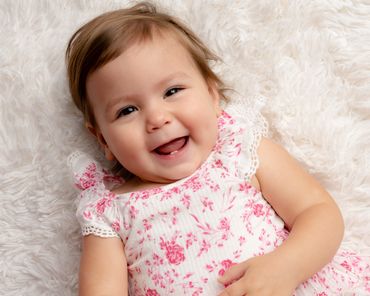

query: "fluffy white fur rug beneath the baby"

left=0, top=0, right=370, bottom=296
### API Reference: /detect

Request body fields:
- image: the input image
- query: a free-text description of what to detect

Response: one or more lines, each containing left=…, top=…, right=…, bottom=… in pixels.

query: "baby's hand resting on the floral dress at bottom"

left=218, top=252, right=299, bottom=296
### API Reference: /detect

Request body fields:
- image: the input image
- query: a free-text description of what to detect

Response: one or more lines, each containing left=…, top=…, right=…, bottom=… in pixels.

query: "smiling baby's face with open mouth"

left=86, top=36, right=220, bottom=183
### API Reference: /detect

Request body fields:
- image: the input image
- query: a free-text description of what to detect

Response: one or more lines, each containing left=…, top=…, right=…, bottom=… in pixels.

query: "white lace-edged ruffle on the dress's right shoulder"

left=227, top=97, right=268, bottom=182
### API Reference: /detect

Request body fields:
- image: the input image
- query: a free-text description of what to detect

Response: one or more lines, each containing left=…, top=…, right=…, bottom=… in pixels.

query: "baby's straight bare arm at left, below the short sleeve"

left=79, top=235, right=128, bottom=296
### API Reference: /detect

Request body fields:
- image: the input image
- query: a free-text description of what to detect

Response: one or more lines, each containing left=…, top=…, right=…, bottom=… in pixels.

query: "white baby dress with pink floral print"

left=75, top=112, right=370, bottom=296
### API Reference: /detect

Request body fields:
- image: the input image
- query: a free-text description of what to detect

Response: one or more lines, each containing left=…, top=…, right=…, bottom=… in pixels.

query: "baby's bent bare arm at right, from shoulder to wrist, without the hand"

left=257, top=140, right=344, bottom=281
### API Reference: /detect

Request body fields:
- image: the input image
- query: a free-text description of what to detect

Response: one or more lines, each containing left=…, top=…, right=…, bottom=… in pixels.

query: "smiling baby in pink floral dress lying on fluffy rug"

left=66, top=3, right=370, bottom=296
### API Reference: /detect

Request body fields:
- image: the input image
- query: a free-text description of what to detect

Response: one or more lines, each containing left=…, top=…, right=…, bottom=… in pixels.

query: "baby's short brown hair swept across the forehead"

left=66, top=2, right=226, bottom=173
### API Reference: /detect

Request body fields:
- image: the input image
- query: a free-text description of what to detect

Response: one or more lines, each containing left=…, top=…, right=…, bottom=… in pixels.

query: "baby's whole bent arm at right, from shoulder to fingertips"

left=220, top=139, right=344, bottom=296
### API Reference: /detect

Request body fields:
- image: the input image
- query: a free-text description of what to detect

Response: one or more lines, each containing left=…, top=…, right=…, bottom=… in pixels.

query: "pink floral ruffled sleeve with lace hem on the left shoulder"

left=68, top=152, right=122, bottom=237
